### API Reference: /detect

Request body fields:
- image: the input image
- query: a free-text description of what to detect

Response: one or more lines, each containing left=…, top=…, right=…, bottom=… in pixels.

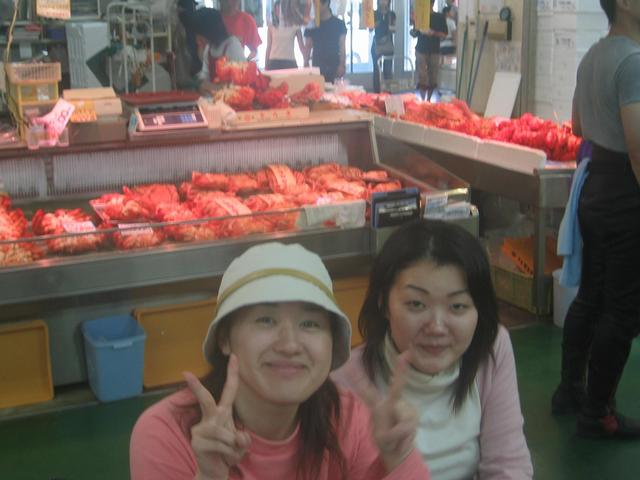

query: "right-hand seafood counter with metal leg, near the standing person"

left=375, top=119, right=575, bottom=314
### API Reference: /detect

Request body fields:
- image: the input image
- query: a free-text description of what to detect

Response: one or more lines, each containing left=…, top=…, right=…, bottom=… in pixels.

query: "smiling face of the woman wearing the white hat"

left=221, top=302, right=333, bottom=408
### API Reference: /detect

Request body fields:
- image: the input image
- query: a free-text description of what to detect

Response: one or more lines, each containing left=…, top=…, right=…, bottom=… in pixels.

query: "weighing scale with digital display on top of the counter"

left=122, top=92, right=208, bottom=136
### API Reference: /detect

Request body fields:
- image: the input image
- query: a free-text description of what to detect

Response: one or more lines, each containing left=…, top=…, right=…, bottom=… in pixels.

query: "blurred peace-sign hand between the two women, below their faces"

left=355, top=351, right=418, bottom=472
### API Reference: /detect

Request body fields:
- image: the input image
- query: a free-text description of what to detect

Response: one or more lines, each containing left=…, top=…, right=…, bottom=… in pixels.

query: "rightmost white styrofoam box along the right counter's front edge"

left=476, top=140, right=547, bottom=175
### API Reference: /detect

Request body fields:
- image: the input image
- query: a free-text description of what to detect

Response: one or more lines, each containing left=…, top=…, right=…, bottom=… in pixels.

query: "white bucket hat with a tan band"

left=203, top=242, right=351, bottom=370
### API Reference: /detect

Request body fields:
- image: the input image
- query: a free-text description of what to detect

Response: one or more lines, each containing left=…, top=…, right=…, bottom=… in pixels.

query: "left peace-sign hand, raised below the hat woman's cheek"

left=184, top=354, right=251, bottom=480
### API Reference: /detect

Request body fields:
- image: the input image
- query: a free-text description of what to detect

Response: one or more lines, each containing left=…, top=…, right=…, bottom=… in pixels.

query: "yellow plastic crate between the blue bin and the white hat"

left=133, top=299, right=216, bottom=388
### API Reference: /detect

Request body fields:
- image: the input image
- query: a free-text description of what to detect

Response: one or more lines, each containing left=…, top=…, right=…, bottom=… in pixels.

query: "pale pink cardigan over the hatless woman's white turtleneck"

left=332, top=326, right=533, bottom=480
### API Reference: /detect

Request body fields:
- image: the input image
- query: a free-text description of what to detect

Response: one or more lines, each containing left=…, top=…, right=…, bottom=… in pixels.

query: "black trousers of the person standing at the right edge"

left=562, top=145, right=640, bottom=416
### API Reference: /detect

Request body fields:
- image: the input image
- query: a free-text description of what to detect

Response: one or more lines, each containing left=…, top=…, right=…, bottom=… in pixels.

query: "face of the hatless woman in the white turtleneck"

left=387, top=260, right=478, bottom=375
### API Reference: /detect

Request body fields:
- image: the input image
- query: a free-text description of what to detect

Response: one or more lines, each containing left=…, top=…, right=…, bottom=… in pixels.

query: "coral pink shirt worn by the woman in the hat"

left=130, top=390, right=430, bottom=480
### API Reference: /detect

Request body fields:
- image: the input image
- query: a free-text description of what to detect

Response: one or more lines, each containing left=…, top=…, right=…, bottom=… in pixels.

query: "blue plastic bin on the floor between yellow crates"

left=82, top=315, right=146, bottom=402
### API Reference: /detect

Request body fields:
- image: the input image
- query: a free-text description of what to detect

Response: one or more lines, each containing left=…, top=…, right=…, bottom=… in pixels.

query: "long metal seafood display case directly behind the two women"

left=0, top=112, right=469, bottom=385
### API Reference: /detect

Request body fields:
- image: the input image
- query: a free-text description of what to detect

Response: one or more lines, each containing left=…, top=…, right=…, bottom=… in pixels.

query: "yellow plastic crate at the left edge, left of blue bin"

left=0, top=320, right=53, bottom=408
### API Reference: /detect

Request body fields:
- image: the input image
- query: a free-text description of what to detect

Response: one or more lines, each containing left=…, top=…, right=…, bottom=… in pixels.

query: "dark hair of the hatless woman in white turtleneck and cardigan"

left=358, top=220, right=498, bottom=412
